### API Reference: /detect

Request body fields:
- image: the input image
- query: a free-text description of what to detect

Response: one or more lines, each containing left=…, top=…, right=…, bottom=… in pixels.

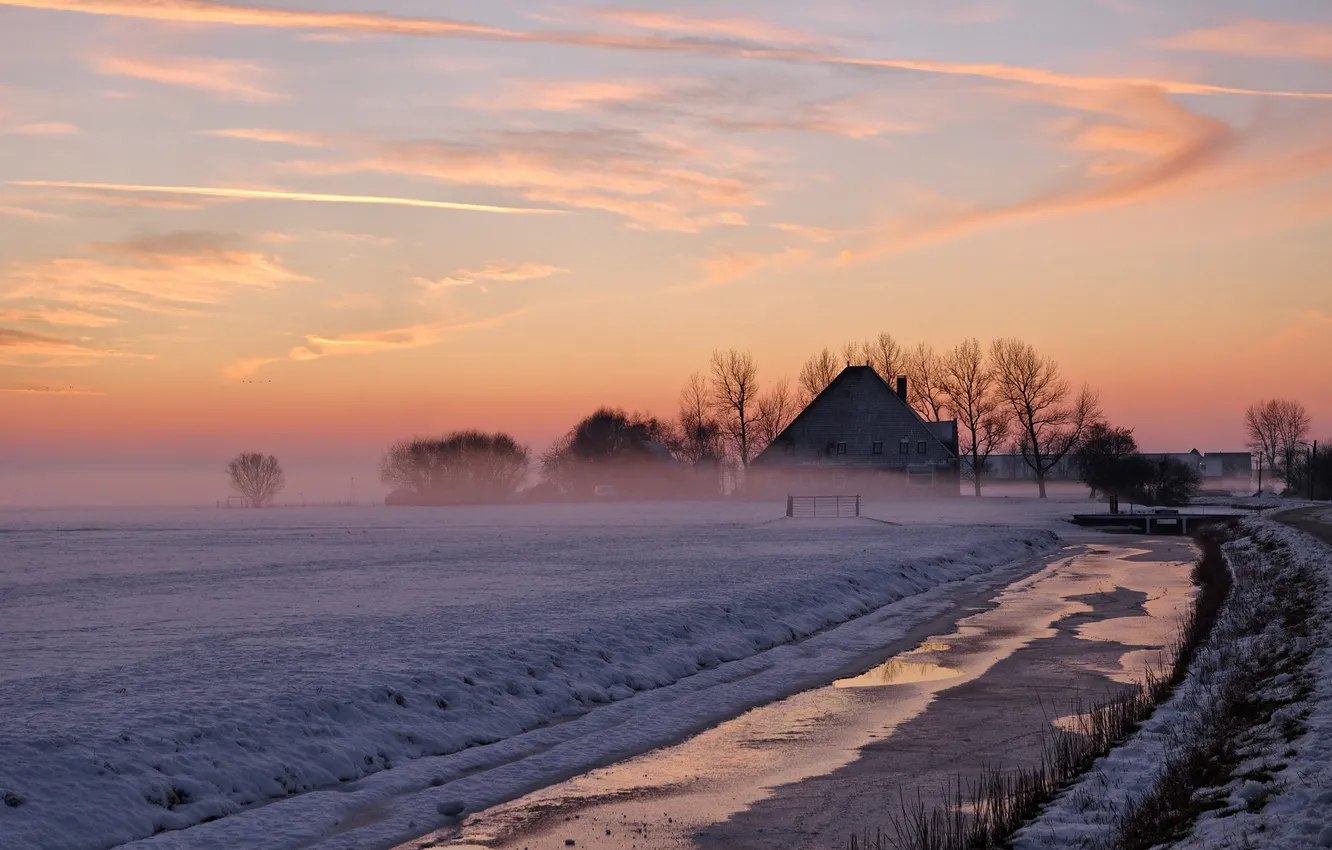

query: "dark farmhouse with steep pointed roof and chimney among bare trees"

left=747, top=366, right=959, bottom=496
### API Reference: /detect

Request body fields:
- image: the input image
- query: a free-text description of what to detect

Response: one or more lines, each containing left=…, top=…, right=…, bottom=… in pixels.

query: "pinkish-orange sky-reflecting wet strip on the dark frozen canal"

left=404, top=546, right=1188, bottom=850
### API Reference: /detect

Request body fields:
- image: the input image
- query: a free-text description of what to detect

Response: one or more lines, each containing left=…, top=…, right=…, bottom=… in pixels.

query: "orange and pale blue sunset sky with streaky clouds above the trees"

left=0, top=0, right=1332, bottom=505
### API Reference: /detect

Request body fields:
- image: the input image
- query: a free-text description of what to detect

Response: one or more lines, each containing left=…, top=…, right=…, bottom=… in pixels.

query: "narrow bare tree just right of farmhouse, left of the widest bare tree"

left=943, top=340, right=1012, bottom=496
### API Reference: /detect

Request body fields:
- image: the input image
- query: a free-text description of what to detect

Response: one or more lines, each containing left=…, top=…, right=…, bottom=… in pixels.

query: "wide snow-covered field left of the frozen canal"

left=0, top=500, right=1070, bottom=850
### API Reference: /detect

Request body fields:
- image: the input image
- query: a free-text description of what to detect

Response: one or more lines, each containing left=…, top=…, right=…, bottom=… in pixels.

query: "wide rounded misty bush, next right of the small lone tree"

left=380, top=430, right=527, bottom=505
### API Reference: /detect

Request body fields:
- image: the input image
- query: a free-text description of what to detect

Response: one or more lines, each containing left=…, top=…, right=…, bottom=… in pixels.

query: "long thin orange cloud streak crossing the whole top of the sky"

left=0, top=0, right=1332, bottom=99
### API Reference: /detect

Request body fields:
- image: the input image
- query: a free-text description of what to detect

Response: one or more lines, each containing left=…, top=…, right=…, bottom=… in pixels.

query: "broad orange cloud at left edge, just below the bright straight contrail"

left=0, top=233, right=309, bottom=316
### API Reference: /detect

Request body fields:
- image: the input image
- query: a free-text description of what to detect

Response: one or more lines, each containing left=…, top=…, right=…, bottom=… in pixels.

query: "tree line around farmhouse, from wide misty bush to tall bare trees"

left=370, top=333, right=1102, bottom=504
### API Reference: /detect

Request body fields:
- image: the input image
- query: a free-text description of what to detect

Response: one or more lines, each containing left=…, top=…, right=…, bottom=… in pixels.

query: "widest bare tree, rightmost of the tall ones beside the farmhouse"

left=990, top=338, right=1102, bottom=498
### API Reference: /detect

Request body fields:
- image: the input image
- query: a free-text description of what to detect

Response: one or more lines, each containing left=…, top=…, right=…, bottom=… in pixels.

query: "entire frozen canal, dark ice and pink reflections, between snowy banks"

left=404, top=534, right=1195, bottom=850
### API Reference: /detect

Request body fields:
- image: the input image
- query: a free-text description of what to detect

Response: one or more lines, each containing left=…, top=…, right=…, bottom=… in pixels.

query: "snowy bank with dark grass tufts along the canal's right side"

left=1014, top=518, right=1332, bottom=850
